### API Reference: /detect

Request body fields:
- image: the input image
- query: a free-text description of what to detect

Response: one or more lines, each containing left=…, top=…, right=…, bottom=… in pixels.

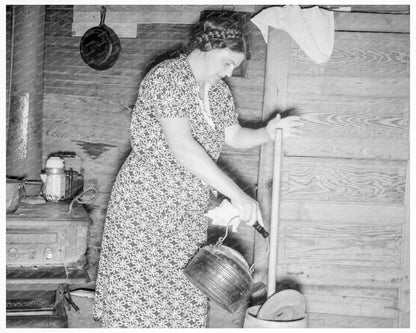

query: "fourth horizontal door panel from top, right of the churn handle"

left=278, top=220, right=403, bottom=268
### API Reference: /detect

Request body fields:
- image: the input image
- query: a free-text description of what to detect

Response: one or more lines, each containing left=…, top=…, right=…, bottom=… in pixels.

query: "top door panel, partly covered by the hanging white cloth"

left=290, top=32, right=410, bottom=77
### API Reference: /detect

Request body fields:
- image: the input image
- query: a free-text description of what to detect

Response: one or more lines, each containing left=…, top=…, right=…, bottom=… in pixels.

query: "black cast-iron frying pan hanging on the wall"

left=80, top=6, right=121, bottom=70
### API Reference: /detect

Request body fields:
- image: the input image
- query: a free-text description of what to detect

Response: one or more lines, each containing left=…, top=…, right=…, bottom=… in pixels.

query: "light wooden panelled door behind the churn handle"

left=255, top=13, right=409, bottom=327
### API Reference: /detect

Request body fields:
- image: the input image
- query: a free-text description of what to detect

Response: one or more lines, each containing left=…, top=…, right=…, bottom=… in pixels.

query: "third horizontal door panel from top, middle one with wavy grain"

left=282, top=157, right=406, bottom=205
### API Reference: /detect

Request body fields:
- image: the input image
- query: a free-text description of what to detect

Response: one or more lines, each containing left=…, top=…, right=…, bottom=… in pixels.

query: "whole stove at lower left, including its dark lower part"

left=6, top=202, right=91, bottom=327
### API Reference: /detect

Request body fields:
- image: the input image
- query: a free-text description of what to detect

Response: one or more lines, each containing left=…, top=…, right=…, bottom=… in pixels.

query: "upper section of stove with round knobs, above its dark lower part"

left=6, top=202, right=91, bottom=285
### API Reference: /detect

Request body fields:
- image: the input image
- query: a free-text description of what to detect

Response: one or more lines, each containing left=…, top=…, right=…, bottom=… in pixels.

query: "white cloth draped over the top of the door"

left=251, top=5, right=334, bottom=64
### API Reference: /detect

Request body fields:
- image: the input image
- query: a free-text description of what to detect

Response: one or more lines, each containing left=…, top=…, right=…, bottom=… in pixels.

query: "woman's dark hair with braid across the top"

left=185, top=17, right=248, bottom=58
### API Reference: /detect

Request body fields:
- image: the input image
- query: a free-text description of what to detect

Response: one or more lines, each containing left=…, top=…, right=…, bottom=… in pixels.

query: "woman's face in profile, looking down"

left=199, top=48, right=245, bottom=84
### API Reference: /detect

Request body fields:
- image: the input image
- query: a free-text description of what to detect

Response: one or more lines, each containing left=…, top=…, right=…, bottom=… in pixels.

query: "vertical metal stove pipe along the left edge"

left=6, top=5, right=45, bottom=179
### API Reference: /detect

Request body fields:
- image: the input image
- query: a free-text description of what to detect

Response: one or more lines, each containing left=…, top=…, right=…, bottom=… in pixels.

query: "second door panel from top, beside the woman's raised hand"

left=288, top=94, right=410, bottom=139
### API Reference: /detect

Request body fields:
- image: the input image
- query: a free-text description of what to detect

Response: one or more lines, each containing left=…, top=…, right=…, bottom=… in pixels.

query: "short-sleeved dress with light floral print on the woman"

left=93, top=56, right=237, bottom=328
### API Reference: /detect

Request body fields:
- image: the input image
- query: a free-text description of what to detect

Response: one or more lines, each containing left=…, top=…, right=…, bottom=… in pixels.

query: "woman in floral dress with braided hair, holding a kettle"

left=94, top=19, right=300, bottom=328
